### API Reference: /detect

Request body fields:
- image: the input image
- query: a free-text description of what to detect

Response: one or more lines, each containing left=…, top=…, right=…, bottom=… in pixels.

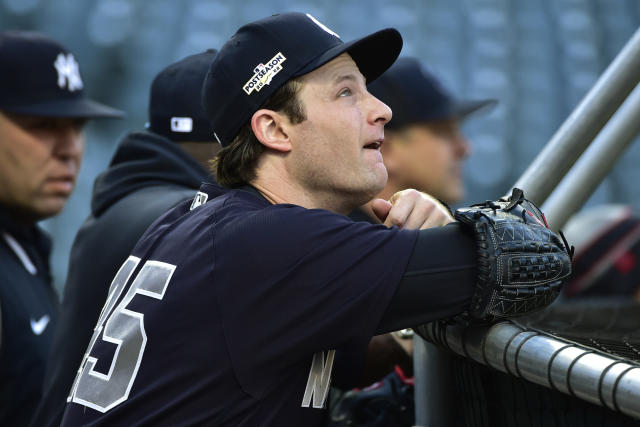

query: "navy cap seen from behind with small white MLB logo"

left=148, top=49, right=216, bottom=142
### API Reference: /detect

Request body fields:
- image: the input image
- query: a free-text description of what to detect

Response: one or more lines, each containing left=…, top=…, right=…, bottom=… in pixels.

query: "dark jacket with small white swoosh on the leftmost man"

left=0, top=206, right=58, bottom=426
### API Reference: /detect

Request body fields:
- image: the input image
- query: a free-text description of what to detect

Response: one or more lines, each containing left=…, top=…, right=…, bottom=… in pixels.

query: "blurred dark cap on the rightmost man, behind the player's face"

left=368, top=57, right=497, bottom=129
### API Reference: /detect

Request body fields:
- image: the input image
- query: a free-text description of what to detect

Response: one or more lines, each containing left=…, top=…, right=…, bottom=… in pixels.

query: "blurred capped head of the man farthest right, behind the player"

left=358, top=57, right=496, bottom=218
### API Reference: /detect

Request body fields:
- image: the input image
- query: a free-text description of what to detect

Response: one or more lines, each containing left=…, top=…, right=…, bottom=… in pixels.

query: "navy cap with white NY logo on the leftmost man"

left=0, top=31, right=123, bottom=119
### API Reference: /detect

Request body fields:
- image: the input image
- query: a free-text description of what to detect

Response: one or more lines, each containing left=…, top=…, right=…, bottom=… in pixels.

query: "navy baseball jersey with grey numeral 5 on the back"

left=62, top=185, right=417, bottom=426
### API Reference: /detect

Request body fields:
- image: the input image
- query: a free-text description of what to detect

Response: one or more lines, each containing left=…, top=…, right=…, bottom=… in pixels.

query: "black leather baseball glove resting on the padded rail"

left=455, top=188, right=573, bottom=321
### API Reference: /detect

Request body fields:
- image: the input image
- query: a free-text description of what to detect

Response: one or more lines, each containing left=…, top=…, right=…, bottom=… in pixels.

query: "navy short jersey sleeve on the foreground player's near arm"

left=213, top=205, right=417, bottom=396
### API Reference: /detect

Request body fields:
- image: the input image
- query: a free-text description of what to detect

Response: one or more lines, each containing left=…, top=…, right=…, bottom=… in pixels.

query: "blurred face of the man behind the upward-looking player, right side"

left=383, top=119, right=470, bottom=203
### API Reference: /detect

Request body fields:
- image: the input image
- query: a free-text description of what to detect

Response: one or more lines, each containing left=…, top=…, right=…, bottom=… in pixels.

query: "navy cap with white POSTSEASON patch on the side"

left=202, top=12, right=402, bottom=146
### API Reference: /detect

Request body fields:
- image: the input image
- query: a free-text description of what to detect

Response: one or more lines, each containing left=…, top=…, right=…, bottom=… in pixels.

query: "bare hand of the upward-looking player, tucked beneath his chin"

left=371, top=189, right=455, bottom=230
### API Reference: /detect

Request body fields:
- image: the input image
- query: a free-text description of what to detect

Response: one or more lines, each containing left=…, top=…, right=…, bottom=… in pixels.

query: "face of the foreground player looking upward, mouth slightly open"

left=287, top=54, right=391, bottom=209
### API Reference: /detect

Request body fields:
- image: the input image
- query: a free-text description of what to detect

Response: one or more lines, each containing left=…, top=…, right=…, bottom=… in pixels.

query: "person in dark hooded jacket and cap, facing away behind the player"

left=32, top=50, right=219, bottom=426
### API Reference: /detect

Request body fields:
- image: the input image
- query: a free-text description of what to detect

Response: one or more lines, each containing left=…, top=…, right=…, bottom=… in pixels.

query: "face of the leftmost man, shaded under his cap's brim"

left=0, top=112, right=85, bottom=223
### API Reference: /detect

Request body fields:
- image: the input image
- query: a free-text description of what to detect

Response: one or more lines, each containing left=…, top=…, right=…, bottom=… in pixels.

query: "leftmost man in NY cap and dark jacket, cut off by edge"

left=0, top=31, right=122, bottom=426
